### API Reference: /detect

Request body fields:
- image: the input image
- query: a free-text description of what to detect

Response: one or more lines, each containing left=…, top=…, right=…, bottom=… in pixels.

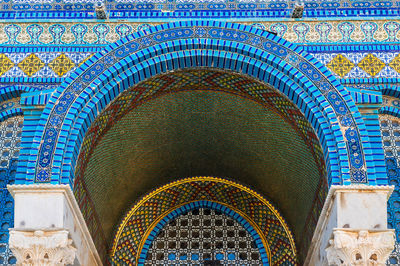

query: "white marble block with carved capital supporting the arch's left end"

left=8, top=184, right=102, bottom=266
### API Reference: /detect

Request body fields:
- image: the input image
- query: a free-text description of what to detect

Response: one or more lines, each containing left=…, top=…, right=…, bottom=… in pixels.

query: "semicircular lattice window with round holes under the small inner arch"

left=145, top=208, right=268, bottom=266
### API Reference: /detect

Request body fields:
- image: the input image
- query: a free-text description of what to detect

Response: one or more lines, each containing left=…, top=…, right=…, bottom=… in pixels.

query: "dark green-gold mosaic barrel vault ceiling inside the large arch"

left=75, top=69, right=325, bottom=262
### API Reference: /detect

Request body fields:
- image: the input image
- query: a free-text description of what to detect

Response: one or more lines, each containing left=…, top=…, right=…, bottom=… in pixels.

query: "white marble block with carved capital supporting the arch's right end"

left=304, top=185, right=394, bottom=266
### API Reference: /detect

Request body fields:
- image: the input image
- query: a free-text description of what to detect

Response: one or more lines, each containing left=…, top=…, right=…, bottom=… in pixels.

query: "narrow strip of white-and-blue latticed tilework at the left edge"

left=0, top=116, right=23, bottom=265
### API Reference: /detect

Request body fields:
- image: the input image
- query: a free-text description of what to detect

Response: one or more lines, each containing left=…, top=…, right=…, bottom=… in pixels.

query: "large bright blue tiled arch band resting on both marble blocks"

left=18, top=21, right=376, bottom=184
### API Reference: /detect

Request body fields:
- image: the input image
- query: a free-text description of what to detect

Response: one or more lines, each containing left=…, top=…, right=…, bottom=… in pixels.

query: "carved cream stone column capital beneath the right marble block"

left=326, top=229, right=395, bottom=266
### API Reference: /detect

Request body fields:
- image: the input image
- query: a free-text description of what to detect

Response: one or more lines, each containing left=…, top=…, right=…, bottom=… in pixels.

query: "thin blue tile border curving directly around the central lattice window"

left=137, top=200, right=271, bottom=265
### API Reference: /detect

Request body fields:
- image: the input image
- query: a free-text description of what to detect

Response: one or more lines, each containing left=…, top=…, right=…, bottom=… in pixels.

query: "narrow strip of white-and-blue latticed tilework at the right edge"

left=379, top=115, right=400, bottom=265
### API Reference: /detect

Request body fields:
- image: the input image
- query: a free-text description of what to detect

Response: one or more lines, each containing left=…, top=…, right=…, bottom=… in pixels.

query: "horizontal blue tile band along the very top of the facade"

left=0, top=0, right=400, bottom=19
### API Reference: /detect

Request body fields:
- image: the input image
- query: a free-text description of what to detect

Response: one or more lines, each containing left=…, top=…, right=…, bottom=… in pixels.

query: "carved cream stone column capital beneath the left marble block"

left=9, top=230, right=76, bottom=266
